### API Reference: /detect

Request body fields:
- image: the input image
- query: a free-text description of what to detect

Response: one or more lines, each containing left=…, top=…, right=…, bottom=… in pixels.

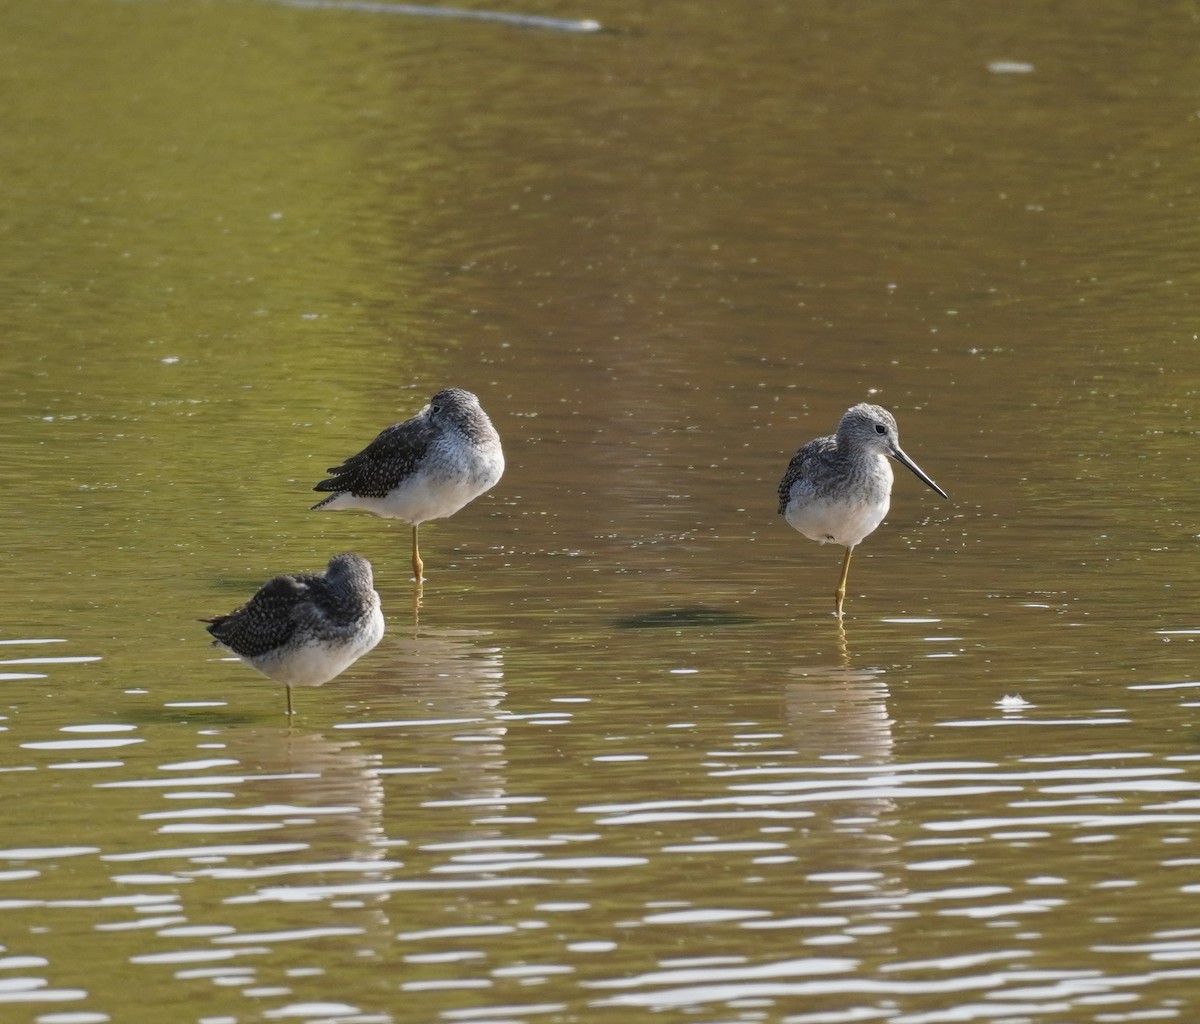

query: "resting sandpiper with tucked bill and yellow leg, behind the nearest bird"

left=313, top=388, right=504, bottom=583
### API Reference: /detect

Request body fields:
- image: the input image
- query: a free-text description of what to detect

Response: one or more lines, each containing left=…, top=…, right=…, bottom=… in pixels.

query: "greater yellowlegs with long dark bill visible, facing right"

left=779, top=402, right=949, bottom=618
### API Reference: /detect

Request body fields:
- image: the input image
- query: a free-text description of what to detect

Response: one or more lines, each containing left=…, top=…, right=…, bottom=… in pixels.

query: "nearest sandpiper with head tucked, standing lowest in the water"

left=203, top=555, right=383, bottom=718
